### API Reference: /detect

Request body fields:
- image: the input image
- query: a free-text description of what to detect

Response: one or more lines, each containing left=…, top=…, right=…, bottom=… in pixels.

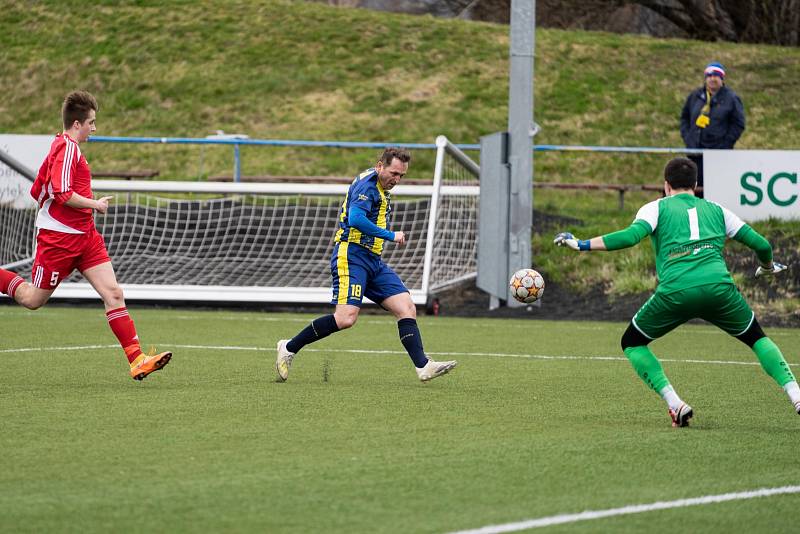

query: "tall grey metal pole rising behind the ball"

left=506, top=0, right=537, bottom=305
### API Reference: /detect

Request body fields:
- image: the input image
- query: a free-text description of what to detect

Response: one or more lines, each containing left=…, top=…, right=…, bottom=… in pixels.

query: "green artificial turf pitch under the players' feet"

left=0, top=305, right=800, bottom=532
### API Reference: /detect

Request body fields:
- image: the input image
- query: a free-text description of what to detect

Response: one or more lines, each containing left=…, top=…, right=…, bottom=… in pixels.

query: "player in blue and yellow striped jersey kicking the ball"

left=275, top=148, right=456, bottom=382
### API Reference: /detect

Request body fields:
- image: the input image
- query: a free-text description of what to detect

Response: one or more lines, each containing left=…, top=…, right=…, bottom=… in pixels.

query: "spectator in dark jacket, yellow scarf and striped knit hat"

left=681, top=63, right=744, bottom=197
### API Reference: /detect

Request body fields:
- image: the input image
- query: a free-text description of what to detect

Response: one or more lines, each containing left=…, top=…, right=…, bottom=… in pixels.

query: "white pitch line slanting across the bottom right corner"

left=452, top=486, right=800, bottom=534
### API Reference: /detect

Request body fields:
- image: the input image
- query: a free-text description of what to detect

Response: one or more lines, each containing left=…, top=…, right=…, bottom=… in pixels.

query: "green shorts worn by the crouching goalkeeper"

left=632, top=284, right=754, bottom=339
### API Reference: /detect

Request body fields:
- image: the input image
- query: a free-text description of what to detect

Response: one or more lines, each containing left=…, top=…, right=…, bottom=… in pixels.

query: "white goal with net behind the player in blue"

left=0, top=136, right=480, bottom=304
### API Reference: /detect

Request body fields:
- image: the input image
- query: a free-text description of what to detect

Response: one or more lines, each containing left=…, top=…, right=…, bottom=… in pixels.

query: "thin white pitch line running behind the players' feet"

left=0, top=343, right=780, bottom=365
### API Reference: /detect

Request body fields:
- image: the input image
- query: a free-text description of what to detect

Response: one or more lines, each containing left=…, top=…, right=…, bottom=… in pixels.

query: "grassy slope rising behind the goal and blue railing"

left=0, top=1, right=800, bottom=310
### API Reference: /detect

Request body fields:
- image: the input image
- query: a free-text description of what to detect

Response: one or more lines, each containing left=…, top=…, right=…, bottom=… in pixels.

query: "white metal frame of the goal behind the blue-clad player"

left=3, top=136, right=480, bottom=305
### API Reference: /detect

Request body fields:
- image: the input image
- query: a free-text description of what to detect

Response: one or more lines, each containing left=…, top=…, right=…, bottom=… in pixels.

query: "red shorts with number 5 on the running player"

left=31, top=228, right=111, bottom=289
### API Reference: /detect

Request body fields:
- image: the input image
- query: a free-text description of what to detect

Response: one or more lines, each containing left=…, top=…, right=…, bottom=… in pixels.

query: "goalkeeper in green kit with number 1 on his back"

left=554, top=158, right=800, bottom=427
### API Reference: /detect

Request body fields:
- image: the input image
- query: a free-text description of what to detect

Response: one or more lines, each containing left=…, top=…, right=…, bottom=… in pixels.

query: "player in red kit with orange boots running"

left=0, top=91, right=172, bottom=380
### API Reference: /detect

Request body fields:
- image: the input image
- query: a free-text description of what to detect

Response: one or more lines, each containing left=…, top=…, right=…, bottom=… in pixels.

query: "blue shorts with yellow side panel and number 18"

left=331, top=243, right=408, bottom=306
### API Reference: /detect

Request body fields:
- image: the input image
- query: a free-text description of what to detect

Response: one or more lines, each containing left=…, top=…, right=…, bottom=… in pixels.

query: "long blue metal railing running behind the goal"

left=89, top=135, right=703, bottom=182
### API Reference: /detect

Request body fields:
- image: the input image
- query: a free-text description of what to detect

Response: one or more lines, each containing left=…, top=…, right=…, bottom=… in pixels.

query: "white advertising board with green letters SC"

left=703, top=150, right=800, bottom=221
